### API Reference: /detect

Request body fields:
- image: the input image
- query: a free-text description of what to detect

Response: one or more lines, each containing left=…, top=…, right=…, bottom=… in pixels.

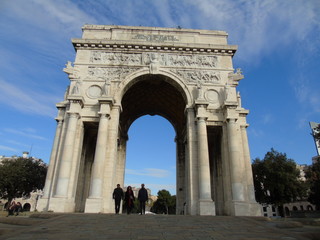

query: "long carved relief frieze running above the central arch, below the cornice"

left=90, top=51, right=218, bottom=68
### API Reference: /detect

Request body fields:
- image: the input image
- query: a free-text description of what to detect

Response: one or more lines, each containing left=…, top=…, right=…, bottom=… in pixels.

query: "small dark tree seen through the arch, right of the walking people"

left=151, top=189, right=176, bottom=214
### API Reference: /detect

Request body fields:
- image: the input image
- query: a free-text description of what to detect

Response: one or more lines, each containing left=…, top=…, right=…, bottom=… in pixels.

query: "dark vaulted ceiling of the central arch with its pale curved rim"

left=117, top=71, right=191, bottom=135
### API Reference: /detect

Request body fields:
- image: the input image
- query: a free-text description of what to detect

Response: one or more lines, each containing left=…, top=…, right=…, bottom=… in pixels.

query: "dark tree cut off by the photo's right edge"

left=306, top=161, right=320, bottom=210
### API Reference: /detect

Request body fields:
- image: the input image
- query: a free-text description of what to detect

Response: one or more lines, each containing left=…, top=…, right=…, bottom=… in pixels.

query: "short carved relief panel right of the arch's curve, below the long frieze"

left=172, top=70, right=220, bottom=83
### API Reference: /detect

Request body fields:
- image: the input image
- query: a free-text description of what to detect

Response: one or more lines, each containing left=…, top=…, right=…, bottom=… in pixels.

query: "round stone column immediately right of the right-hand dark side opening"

left=227, top=118, right=244, bottom=201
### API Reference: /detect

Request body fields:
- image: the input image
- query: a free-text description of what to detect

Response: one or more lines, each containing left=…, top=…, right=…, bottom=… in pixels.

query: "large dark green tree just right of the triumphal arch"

left=252, top=148, right=306, bottom=215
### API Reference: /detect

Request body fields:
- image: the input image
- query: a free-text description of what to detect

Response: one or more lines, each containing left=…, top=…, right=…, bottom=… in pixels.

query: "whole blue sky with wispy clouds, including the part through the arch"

left=0, top=0, right=320, bottom=194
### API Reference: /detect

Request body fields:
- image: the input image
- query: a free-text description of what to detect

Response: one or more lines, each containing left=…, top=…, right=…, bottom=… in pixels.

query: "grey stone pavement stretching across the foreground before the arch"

left=0, top=213, right=320, bottom=240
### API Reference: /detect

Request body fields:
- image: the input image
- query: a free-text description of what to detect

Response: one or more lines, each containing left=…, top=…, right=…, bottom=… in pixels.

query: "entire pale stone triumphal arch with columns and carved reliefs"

left=38, top=25, right=261, bottom=216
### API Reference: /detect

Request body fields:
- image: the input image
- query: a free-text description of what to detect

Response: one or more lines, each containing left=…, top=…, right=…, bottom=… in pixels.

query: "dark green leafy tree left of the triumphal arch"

left=0, top=157, right=47, bottom=201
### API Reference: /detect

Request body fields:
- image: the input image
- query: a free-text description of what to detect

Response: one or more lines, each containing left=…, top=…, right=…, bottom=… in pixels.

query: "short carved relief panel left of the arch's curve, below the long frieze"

left=85, top=67, right=137, bottom=82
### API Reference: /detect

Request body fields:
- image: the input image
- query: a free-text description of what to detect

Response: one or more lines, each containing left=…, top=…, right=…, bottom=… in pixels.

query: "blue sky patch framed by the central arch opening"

left=124, top=115, right=176, bottom=199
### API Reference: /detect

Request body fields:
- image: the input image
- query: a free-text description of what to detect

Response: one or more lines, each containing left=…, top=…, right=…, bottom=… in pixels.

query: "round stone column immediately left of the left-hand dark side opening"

left=55, top=112, right=79, bottom=197
